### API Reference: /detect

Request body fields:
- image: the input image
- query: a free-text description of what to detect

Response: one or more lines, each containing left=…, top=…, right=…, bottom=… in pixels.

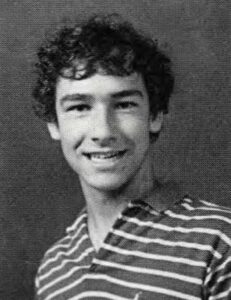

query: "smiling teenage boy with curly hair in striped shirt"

left=34, top=16, right=231, bottom=300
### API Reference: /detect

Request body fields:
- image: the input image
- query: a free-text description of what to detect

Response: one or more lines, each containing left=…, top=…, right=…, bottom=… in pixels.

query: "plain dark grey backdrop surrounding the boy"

left=0, top=0, right=231, bottom=300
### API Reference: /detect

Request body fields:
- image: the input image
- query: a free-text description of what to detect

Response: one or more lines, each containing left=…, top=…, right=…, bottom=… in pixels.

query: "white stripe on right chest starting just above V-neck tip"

left=102, top=244, right=206, bottom=267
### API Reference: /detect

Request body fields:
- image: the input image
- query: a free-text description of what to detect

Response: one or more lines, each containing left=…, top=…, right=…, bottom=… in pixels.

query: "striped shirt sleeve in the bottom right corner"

left=205, top=247, right=231, bottom=300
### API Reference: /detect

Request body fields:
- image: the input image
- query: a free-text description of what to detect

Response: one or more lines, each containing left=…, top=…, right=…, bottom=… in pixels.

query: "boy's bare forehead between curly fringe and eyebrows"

left=56, top=73, right=146, bottom=100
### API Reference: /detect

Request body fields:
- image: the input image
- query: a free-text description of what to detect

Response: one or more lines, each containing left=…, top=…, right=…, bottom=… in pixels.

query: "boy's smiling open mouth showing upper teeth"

left=83, top=150, right=127, bottom=162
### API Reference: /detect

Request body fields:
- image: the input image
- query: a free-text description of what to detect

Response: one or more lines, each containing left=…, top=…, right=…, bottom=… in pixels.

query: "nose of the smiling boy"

left=90, top=107, right=118, bottom=146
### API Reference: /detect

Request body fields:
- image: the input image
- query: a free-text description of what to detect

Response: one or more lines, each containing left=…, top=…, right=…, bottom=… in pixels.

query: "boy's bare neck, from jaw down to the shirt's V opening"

left=82, top=150, right=155, bottom=250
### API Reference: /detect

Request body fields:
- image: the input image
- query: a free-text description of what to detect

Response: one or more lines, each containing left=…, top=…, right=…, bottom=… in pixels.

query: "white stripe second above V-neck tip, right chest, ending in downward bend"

left=112, top=229, right=222, bottom=259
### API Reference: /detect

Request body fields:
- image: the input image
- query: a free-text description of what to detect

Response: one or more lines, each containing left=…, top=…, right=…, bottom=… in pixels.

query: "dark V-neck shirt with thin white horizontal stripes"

left=36, top=197, right=231, bottom=300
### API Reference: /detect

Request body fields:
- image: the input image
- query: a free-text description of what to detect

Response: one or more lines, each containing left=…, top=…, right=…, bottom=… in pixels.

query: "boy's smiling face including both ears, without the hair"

left=48, top=73, right=162, bottom=191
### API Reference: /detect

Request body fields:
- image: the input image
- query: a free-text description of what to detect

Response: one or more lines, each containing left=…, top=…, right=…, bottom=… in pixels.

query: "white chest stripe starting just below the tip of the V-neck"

left=94, top=259, right=202, bottom=285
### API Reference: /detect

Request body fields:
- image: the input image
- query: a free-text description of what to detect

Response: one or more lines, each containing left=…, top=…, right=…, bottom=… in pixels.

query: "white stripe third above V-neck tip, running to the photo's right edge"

left=122, top=216, right=231, bottom=246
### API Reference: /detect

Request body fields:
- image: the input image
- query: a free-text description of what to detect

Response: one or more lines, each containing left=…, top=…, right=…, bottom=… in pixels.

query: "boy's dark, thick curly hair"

left=33, top=14, right=174, bottom=122
